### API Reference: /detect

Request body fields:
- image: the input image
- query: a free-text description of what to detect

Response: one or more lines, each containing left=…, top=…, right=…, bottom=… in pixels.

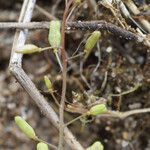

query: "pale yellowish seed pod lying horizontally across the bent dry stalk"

left=16, top=44, right=42, bottom=54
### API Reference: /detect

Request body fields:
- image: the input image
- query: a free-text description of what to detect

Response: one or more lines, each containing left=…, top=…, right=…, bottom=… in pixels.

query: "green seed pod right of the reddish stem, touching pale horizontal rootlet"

left=88, top=104, right=107, bottom=116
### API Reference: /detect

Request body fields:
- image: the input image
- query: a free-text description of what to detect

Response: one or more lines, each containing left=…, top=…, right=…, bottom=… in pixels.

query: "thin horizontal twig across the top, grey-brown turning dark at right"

left=0, top=21, right=144, bottom=42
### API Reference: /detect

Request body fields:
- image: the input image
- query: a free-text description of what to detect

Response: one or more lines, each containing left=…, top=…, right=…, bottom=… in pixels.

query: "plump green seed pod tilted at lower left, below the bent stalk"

left=15, top=116, right=37, bottom=140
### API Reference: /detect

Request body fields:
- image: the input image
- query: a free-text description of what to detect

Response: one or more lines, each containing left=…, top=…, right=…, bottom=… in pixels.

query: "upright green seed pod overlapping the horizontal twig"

left=48, top=20, right=61, bottom=48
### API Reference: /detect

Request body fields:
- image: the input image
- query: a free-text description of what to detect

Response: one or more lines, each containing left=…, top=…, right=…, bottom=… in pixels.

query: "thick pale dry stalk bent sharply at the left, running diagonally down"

left=9, top=0, right=83, bottom=150
